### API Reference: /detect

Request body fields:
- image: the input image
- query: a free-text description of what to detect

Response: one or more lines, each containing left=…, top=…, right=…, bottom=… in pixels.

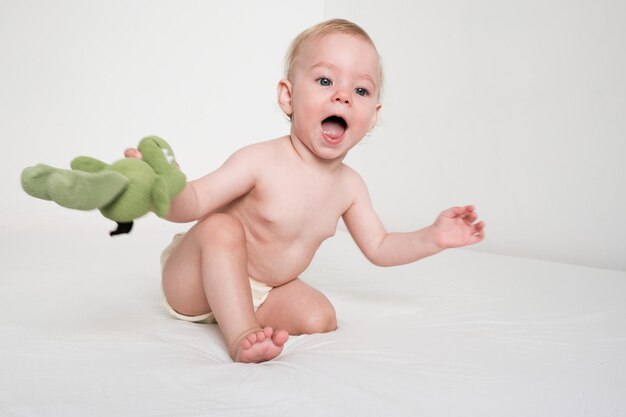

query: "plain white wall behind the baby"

left=0, top=0, right=626, bottom=270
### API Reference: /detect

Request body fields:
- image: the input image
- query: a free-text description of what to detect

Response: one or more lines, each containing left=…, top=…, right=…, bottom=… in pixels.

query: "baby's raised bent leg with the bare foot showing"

left=163, top=214, right=288, bottom=362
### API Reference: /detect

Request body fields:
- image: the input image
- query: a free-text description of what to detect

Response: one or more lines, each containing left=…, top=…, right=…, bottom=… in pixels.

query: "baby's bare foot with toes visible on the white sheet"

left=231, top=327, right=289, bottom=363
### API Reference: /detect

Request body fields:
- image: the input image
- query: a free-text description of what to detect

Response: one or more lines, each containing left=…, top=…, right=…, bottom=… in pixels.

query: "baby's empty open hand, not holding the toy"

left=432, top=206, right=485, bottom=249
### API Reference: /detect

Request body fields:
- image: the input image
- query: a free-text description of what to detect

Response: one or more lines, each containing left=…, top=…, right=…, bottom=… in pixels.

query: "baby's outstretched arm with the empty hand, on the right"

left=343, top=172, right=485, bottom=266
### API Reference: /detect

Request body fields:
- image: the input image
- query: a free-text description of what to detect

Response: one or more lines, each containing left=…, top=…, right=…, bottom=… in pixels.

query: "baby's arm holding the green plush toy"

left=124, top=147, right=259, bottom=223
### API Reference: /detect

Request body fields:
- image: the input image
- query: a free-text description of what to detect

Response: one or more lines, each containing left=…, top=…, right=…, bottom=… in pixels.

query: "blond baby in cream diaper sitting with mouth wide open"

left=126, top=19, right=484, bottom=362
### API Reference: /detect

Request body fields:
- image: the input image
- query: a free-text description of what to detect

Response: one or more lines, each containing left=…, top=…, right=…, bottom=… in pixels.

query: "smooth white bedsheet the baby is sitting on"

left=0, top=227, right=626, bottom=417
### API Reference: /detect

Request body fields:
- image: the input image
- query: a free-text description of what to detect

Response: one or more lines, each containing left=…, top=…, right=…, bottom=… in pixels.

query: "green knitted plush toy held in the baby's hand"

left=22, top=136, right=186, bottom=236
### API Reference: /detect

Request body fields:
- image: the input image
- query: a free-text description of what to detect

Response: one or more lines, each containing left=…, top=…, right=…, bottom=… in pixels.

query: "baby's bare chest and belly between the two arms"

left=219, top=137, right=354, bottom=286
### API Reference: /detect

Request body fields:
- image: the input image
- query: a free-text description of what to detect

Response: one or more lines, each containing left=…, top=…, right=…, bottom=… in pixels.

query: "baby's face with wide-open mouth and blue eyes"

left=281, top=33, right=381, bottom=159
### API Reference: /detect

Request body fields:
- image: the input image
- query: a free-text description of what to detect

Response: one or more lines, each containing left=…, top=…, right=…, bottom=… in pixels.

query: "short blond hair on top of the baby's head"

left=284, top=19, right=383, bottom=93
